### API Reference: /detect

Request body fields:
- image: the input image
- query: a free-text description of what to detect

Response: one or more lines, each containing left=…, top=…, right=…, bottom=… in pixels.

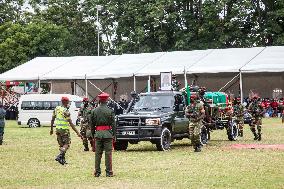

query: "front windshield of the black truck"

left=134, top=95, right=174, bottom=110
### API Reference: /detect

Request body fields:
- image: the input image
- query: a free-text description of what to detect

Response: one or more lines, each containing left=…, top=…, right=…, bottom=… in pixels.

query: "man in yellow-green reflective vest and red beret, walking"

left=50, top=97, right=81, bottom=165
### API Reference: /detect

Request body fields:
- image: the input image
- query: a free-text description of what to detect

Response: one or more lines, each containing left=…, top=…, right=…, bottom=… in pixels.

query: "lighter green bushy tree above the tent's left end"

left=0, top=22, right=71, bottom=73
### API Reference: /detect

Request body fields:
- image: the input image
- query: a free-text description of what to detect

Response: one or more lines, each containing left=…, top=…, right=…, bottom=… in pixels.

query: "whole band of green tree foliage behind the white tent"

left=0, top=0, right=284, bottom=72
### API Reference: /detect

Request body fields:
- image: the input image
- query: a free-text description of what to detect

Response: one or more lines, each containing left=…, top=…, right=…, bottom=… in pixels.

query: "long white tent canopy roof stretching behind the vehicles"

left=0, top=46, right=284, bottom=81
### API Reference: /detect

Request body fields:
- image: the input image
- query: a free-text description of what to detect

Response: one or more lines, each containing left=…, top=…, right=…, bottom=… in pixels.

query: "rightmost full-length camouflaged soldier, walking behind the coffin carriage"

left=248, top=96, right=264, bottom=141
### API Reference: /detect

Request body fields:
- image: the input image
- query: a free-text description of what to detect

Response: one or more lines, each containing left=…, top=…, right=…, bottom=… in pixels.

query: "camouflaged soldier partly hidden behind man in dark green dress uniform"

left=78, top=98, right=93, bottom=151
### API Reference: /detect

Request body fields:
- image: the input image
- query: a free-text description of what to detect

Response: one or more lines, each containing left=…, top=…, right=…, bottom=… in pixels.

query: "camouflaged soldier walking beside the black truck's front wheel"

left=186, top=95, right=205, bottom=152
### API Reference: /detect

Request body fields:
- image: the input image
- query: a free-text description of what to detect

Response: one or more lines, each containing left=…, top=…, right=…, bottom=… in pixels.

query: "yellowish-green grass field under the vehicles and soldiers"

left=0, top=119, right=284, bottom=189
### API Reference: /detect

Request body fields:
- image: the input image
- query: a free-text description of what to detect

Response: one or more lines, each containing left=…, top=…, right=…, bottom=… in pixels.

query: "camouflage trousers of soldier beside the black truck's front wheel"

left=189, top=121, right=202, bottom=147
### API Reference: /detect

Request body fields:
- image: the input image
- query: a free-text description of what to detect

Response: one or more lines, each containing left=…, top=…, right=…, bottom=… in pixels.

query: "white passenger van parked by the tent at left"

left=18, top=94, right=82, bottom=127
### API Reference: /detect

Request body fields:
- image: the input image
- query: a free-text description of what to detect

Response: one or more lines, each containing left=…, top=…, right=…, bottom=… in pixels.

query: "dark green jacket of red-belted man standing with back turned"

left=90, top=104, right=115, bottom=138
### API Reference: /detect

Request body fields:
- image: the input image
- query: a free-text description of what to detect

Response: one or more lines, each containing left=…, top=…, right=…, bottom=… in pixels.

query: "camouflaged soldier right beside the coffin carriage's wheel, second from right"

left=234, top=98, right=245, bottom=137
